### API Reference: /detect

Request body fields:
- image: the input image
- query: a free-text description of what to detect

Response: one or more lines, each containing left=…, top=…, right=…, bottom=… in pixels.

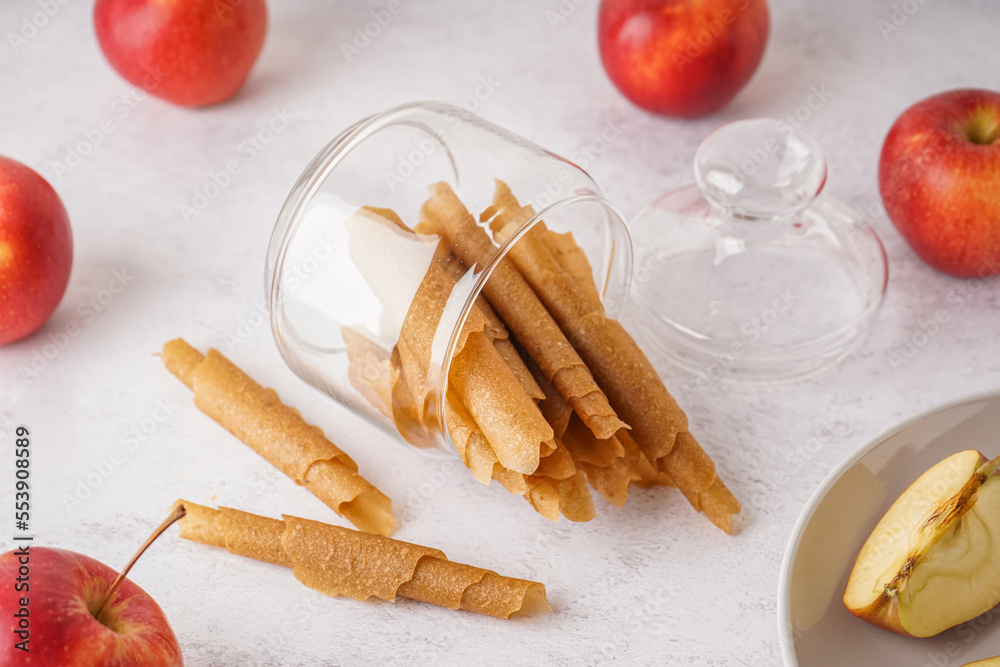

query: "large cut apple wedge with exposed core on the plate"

left=844, top=450, right=1000, bottom=637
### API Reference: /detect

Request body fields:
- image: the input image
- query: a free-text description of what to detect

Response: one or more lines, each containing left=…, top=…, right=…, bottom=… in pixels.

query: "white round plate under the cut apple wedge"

left=778, top=391, right=1000, bottom=667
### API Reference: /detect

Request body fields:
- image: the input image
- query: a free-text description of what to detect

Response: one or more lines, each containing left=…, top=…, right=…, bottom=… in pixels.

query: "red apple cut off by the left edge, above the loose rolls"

left=0, top=157, right=73, bottom=345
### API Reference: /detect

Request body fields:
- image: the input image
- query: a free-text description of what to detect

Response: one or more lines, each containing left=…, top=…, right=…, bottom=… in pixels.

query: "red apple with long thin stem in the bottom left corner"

left=0, top=547, right=184, bottom=667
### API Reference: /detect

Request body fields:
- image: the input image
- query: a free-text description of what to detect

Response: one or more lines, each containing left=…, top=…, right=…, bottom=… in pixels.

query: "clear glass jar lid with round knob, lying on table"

left=628, top=118, right=888, bottom=383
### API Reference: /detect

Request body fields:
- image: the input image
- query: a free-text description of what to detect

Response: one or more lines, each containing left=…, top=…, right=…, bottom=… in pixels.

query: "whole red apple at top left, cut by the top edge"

left=94, top=0, right=267, bottom=107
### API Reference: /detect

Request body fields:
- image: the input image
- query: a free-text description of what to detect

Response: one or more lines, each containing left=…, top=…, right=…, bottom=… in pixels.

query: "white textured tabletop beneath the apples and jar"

left=0, top=0, right=1000, bottom=666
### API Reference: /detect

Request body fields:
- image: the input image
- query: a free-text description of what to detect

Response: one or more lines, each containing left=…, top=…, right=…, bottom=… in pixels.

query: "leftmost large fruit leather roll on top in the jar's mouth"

left=347, top=208, right=553, bottom=474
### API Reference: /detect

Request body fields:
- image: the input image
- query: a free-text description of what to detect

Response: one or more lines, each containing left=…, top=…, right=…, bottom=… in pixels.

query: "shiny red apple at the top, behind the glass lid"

left=598, top=0, right=770, bottom=118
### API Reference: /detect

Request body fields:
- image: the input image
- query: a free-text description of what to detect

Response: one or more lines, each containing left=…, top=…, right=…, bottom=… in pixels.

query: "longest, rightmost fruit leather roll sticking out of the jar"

left=490, top=187, right=740, bottom=533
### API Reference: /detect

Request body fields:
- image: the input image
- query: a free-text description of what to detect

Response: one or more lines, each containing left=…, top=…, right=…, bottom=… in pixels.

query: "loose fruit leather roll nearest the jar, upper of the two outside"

left=163, top=338, right=396, bottom=535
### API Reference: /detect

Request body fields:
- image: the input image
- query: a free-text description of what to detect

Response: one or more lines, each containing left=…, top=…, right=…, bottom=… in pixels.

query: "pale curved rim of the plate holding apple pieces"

left=777, top=387, right=1000, bottom=667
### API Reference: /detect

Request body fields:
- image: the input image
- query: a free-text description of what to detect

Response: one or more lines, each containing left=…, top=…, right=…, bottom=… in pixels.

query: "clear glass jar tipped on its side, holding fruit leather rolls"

left=265, top=102, right=632, bottom=451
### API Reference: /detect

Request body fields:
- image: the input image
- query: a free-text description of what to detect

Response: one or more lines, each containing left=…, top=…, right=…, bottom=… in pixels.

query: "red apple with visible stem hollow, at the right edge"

left=878, top=90, right=1000, bottom=277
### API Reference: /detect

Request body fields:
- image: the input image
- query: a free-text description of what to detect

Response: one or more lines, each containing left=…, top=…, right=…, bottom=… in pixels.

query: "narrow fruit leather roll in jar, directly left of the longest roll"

left=417, top=183, right=625, bottom=438
